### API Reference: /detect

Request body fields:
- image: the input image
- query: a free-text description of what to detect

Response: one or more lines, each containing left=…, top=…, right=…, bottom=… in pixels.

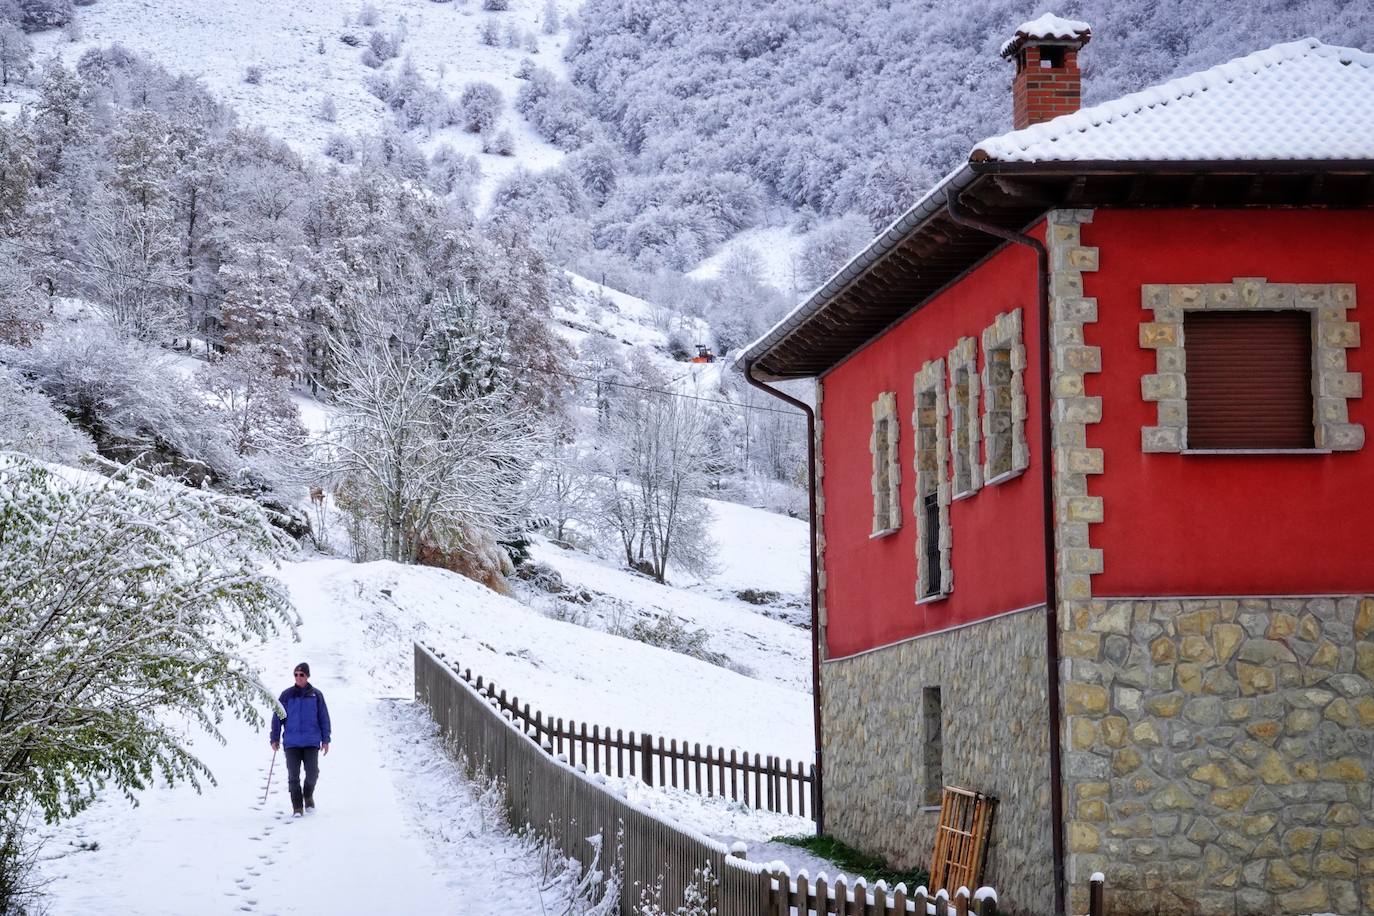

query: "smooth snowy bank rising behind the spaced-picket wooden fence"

left=306, top=560, right=811, bottom=758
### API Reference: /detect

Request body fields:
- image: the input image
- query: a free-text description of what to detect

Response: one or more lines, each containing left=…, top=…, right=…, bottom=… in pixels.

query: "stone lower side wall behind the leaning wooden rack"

left=820, top=608, right=1054, bottom=915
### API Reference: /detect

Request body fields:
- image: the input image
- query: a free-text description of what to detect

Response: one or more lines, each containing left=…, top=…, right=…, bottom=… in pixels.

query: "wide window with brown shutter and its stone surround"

left=1140, top=277, right=1364, bottom=452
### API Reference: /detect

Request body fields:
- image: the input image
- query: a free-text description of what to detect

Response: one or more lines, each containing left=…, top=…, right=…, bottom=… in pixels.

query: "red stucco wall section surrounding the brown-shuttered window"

left=1083, top=210, right=1374, bottom=596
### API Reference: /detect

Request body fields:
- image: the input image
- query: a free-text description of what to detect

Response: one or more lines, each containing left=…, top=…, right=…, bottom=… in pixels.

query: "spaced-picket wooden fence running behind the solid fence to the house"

left=452, top=650, right=819, bottom=820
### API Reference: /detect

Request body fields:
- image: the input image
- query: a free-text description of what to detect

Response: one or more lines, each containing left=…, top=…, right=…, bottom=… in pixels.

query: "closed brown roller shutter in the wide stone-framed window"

left=1183, top=310, right=1315, bottom=449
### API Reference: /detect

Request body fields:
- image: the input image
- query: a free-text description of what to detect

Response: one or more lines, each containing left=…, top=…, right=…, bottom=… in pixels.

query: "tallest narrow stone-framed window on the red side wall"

left=912, top=360, right=954, bottom=600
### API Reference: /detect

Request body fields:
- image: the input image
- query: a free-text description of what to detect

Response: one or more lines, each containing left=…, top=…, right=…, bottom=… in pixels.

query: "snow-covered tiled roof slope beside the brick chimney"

left=970, top=38, right=1374, bottom=162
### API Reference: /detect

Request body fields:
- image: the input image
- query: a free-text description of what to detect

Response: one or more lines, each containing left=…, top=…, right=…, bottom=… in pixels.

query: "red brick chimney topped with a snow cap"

left=1002, top=12, right=1092, bottom=130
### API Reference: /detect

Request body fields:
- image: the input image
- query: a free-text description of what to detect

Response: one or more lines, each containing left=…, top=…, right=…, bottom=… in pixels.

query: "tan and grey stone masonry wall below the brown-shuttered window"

left=1061, top=596, right=1374, bottom=916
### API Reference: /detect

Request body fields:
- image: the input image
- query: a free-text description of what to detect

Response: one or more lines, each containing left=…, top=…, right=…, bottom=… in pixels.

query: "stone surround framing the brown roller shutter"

left=1140, top=277, right=1364, bottom=455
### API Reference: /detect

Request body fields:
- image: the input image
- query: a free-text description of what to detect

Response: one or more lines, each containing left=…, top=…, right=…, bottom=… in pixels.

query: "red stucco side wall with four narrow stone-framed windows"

left=822, top=233, right=1044, bottom=658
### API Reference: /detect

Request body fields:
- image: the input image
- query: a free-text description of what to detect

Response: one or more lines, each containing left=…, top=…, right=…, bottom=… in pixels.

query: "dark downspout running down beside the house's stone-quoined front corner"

left=947, top=190, right=1068, bottom=915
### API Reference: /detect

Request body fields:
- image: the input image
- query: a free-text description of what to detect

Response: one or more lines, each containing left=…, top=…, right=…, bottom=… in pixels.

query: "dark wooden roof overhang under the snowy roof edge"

left=736, top=159, right=1374, bottom=382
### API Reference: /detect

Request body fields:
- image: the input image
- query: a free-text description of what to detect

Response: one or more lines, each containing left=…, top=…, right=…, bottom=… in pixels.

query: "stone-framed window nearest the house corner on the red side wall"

left=982, top=309, right=1031, bottom=483
